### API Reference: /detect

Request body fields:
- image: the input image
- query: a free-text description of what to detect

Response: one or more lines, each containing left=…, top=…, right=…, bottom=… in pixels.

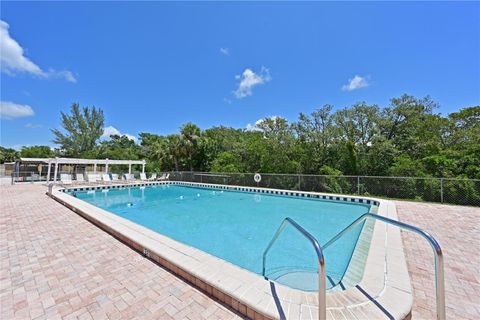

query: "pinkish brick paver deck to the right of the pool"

left=396, top=201, right=480, bottom=319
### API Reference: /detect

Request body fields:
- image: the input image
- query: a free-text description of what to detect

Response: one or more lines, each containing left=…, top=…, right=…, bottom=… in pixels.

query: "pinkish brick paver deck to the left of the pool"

left=0, top=184, right=244, bottom=320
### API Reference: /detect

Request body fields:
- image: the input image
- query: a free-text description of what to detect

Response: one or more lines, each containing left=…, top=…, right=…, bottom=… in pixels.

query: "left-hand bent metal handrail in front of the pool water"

left=262, top=217, right=327, bottom=320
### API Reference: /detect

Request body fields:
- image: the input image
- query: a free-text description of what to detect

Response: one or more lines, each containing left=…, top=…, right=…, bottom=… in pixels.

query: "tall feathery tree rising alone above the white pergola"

left=52, top=103, right=104, bottom=157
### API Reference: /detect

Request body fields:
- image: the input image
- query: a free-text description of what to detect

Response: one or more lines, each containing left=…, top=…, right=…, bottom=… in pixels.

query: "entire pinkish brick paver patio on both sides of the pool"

left=0, top=184, right=480, bottom=320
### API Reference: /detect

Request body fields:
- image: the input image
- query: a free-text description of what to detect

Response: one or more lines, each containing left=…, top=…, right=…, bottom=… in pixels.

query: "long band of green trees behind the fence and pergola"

left=0, top=95, right=480, bottom=179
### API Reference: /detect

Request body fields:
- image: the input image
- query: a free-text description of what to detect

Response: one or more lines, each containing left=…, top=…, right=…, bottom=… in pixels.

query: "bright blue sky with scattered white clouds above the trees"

left=0, top=2, right=480, bottom=148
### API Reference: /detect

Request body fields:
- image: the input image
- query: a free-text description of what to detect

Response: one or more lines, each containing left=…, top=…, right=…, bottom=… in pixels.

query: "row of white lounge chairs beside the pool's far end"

left=60, top=173, right=170, bottom=185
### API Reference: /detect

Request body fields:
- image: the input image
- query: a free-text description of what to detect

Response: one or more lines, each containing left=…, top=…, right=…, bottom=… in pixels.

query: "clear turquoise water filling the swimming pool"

left=76, top=185, right=370, bottom=290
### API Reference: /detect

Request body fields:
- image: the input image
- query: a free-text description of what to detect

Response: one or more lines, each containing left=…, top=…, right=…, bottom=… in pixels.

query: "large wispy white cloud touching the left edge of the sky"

left=0, top=20, right=77, bottom=83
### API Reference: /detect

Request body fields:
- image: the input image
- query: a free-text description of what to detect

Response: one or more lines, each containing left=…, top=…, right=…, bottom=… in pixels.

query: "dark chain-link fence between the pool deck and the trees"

left=166, top=171, right=480, bottom=207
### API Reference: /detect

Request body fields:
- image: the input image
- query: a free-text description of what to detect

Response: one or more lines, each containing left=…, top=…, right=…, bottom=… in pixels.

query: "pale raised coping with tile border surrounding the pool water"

left=50, top=181, right=413, bottom=319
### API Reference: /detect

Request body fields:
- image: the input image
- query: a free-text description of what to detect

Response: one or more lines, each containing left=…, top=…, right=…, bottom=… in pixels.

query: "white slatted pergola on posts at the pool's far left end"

left=20, top=158, right=145, bottom=182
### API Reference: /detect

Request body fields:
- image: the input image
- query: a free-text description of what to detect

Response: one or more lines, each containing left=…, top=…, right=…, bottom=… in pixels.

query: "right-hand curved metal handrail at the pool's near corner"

left=322, top=213, right=446, bottom=320
